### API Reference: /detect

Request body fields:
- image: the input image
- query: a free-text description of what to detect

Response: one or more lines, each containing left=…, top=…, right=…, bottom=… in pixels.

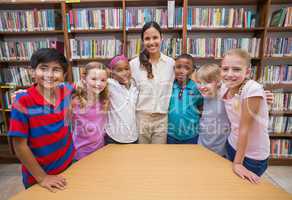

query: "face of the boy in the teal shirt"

left=174, top=58, right=194, bottom=82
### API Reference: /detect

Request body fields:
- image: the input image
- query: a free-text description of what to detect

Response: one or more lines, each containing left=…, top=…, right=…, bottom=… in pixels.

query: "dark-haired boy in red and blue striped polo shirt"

left=8, top=49, right=75, bottom=192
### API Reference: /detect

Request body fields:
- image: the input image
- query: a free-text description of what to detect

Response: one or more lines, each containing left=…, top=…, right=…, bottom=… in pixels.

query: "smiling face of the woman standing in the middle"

left=143, top=27, right=162, bottom=54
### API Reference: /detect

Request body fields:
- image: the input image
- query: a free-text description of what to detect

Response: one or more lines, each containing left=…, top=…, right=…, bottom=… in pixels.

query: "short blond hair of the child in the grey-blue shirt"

left=196, top=63, right=220, bottom=82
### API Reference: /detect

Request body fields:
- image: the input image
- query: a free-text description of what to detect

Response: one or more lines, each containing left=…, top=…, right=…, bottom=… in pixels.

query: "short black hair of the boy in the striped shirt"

left=30, top=48, right=68, bottom=73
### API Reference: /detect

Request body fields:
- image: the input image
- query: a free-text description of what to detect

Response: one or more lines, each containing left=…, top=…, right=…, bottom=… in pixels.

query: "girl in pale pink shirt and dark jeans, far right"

left=221, top=49, right=270, bottom=183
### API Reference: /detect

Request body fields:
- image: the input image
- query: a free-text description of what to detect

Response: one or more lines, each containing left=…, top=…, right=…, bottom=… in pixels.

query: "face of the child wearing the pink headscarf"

left=112, top=60, right=131, bottom=85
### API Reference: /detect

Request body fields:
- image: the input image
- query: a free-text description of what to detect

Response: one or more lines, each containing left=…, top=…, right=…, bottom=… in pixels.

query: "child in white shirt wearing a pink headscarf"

left=105, top=55, right=138, bottom=144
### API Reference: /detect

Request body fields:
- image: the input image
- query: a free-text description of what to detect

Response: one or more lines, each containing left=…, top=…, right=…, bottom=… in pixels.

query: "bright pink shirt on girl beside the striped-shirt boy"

left=72, top=103, right=107, bottom=160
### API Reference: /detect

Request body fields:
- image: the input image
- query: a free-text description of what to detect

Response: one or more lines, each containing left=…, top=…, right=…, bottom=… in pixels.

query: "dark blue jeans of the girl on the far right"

left=226, top=140, right=268, bottom=176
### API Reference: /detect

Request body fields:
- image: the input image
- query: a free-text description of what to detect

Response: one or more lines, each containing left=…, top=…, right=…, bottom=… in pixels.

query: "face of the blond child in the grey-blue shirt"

left=197, top=80, right=219, bottom=98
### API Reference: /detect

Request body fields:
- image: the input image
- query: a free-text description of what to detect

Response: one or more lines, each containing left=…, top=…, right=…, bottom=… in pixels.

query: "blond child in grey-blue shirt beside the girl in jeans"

left=196, top=64, right=230, bottom=156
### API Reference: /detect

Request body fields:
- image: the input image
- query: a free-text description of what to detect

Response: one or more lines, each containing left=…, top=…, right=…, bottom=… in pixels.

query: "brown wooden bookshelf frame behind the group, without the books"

left=0, top=0, right=292, bottom=165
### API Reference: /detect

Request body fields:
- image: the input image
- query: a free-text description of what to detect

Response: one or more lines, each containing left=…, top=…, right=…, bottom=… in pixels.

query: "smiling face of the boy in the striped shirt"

left=34, top=61, right=64, bottom=90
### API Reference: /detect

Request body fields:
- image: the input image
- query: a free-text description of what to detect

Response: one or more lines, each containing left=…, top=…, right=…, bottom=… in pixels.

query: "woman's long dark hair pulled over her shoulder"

left=139, top=21, right=161, bottom=79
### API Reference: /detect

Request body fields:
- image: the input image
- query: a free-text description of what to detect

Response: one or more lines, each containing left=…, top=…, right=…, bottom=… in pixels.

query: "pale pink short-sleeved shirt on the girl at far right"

left=221, top=80, right=270, bottom=160
